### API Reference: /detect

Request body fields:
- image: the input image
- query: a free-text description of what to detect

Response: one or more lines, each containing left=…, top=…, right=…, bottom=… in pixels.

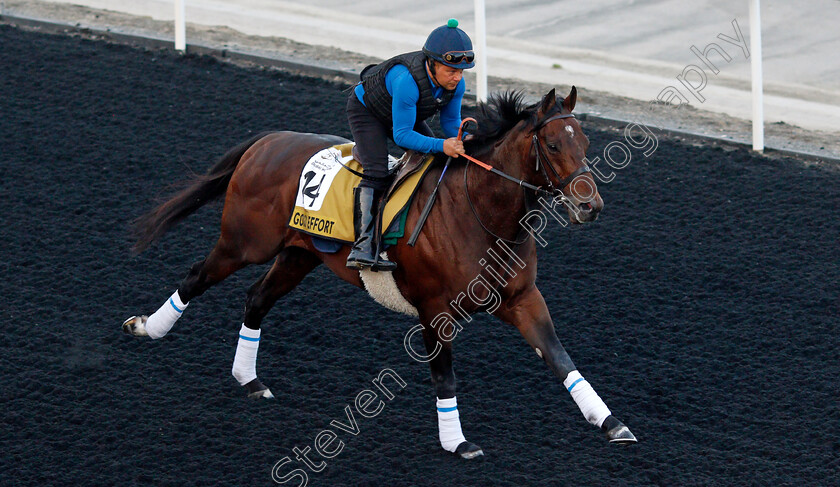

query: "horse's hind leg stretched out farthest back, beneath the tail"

left=122, top=239, right=250, bottom=339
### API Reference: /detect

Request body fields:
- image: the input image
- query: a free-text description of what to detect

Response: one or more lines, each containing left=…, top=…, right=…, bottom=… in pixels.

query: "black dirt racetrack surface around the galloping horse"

left=0, top=26, right=840, bottom=487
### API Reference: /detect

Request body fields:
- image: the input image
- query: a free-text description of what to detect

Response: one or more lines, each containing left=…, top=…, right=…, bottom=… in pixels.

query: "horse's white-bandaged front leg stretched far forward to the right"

left=494, top=286, right=636, bottom=443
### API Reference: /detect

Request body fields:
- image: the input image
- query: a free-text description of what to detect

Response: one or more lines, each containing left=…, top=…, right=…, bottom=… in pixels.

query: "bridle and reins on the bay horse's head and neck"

left=461, top=113, right=591, bottom=245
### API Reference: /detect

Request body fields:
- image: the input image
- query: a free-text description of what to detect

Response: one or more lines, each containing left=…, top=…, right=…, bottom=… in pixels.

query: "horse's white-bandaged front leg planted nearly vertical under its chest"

left=421, top=312, right=484, bottom=460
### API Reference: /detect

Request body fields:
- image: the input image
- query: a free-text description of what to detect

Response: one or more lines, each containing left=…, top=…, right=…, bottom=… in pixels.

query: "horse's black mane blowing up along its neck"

left=465, top=90, right=536, bottom=152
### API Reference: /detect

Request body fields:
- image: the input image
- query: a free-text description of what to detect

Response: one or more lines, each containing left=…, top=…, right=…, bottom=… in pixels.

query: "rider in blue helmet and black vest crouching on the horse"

left=347, top=19, right=475, bottom=271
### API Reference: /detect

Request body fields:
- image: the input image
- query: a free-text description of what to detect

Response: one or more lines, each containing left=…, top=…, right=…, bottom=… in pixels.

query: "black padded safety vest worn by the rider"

left=361, top=51, right=455, bottom=127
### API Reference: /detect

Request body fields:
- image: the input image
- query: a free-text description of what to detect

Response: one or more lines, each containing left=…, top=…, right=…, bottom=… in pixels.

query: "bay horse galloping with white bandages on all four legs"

left=123, top=87, right=636, bottom=458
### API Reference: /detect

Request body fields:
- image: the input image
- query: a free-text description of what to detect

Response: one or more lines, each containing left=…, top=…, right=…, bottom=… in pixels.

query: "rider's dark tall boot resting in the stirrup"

left=347, top=186, right=397, bottom=271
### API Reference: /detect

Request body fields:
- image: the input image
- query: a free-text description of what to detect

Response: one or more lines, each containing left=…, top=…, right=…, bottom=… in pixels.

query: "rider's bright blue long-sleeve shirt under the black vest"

left=356, top=64, right=466, bottom=153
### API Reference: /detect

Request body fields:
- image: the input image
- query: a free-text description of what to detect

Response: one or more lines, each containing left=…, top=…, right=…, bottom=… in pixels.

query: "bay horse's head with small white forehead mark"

left=526, top=86, right=604, bottom=223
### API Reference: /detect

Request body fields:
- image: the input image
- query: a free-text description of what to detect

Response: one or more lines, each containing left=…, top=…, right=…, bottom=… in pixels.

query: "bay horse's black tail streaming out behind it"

left=134, top=132, right=269, bottom=253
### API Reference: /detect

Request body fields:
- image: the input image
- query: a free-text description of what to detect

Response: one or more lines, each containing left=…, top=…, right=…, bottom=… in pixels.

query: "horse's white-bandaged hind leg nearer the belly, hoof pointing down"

left=232, top=247, right=321, bottom=399
